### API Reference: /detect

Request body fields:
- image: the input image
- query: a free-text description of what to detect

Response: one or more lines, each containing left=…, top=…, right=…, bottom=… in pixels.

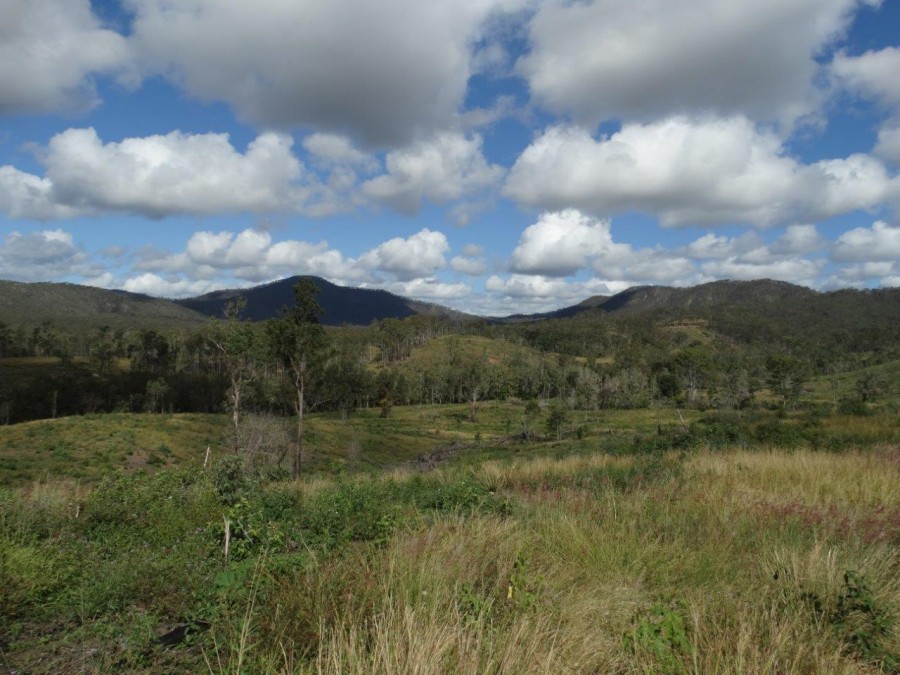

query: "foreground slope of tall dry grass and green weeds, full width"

left=0, top=438, right=900, bottom=674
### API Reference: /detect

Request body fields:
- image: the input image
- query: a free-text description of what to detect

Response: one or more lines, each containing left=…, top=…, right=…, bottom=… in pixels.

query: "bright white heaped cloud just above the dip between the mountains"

left=509, top=209, right=630, bottom=277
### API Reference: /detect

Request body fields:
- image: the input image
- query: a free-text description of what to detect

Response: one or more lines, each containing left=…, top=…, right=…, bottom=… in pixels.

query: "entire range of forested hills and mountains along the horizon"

left=0, top=276, right=900, bottom=333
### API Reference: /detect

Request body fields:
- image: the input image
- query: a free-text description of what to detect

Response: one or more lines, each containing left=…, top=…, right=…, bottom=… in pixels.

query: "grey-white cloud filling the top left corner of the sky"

left=0, top=0, right=129, bottom=114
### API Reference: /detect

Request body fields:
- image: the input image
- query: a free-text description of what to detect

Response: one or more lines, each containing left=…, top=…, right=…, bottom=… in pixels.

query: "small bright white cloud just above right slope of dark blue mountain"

left=358, top=228, right=450, bottom=281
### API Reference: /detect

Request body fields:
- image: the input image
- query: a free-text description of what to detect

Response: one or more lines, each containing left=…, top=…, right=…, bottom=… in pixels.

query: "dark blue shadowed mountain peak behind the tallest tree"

left=175, top=276, right=476, bottom=326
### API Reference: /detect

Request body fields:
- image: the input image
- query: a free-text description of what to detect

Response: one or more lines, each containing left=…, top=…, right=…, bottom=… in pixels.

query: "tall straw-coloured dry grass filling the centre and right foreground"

left=207, top=449, right=900, bottom=674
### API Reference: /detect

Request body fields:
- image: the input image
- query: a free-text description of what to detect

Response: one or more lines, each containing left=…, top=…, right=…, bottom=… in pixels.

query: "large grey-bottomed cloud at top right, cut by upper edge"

left=518, top=0, right=877, bottom=125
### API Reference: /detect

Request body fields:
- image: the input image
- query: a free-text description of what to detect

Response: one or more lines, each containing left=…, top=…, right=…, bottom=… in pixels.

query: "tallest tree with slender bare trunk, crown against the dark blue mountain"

left=266, top=279, right=326, bottom=478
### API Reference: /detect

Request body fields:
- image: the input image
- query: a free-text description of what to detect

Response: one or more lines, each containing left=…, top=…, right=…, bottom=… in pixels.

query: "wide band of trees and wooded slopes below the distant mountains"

left=0, top=287, right=897, bottom=424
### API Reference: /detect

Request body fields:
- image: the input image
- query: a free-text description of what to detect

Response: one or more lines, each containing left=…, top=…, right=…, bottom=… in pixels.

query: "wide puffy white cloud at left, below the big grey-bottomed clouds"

left=44, top=129, right=304, bottom=217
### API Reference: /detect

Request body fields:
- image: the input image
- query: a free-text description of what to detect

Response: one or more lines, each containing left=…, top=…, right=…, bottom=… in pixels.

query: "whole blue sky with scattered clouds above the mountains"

left=0, top=0, right=900, bottom=315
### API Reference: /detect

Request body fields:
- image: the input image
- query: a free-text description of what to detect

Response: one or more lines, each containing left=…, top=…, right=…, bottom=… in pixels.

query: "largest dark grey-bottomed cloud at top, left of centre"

left=128, top=0, right=525, bottom=147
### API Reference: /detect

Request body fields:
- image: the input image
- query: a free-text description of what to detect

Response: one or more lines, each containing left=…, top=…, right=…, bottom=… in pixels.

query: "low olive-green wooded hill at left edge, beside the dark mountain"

left=0, top=280, right=208, bottom=328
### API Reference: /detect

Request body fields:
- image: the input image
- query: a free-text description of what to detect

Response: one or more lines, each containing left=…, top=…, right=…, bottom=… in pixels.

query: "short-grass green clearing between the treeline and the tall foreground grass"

left=0, top=401, right=900, bottom=486
